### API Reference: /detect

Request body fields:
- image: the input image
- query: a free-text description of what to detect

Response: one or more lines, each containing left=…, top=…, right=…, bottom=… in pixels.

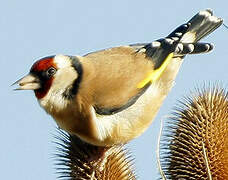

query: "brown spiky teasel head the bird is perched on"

left=55, top=130, right=136, bottom=180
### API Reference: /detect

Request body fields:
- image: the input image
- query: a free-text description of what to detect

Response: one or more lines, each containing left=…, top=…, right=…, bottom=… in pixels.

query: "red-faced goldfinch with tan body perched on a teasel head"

left=14, top=9, right=223, bottom=146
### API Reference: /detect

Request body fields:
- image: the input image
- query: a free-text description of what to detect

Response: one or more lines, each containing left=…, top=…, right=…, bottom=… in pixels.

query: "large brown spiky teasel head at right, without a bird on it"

left=161, top=86, right=228, bottom=180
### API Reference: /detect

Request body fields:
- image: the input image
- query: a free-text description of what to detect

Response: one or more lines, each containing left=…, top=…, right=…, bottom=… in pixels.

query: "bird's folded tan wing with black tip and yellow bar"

left=84, top=24, right=189, bottom=115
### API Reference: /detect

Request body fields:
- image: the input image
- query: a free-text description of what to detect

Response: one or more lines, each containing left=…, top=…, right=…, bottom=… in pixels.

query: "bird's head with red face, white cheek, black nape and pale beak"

left=14, top=55, right=82, bottom=100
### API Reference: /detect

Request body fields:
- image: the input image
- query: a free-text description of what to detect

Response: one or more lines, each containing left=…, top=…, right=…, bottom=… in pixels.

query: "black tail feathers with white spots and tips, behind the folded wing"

left=171, top=9, right=223, bottom=55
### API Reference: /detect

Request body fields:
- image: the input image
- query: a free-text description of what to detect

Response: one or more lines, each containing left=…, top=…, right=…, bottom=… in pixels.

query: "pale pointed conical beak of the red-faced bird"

left=12, top=74, right=41, bottom=90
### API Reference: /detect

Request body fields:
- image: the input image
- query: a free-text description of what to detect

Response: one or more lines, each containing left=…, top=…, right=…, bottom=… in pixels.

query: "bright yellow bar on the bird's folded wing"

left=137, top=53, right=174, bottom=89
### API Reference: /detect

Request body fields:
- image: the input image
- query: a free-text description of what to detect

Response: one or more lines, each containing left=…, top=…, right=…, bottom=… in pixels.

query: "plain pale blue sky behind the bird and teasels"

left=0, top=0, right=228, bottom=180
